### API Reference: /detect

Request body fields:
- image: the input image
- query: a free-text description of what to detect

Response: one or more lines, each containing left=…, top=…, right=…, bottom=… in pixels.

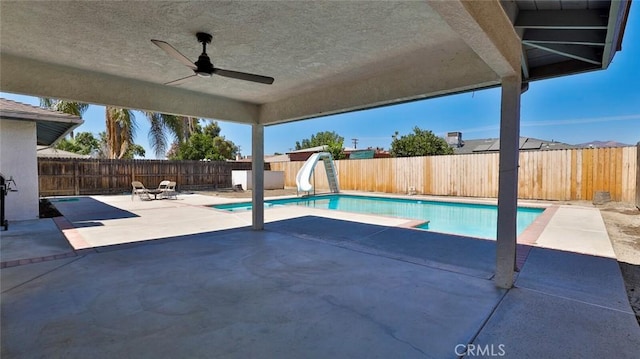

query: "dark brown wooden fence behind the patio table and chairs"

left=38, top=158, right=268, bottom=196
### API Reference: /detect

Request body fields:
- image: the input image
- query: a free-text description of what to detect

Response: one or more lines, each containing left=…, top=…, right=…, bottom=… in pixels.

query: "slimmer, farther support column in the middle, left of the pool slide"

left=251, top=124, right=264, bottom=231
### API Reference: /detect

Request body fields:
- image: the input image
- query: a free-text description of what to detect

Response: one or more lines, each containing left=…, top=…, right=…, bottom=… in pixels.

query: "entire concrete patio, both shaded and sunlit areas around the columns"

left=1, top=195, right=640, bottom=358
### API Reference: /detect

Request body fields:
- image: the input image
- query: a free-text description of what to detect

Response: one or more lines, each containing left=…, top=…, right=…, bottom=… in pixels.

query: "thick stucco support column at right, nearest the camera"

left=495, top=76, right=522, bottom=288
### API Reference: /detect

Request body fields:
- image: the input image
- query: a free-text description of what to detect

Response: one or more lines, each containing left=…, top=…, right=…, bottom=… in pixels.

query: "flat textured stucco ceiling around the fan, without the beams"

left=1, top=1, right=464, bottom=103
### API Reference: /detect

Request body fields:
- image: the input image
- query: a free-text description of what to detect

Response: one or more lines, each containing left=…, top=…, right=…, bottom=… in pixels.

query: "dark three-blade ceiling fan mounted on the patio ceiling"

left=151, top=32, right=273, bottom=85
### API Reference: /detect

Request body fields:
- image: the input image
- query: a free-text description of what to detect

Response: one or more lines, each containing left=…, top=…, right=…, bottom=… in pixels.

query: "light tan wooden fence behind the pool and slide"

left=271, top=147, right=638, bottom=202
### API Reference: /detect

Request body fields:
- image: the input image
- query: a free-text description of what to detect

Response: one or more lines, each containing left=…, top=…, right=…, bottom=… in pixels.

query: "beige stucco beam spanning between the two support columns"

left=259, top=47, right=500, bottom=125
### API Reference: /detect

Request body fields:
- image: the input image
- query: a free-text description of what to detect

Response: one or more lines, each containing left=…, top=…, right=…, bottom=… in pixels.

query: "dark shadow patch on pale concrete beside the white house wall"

left=49, top=197, right=138, bottom=227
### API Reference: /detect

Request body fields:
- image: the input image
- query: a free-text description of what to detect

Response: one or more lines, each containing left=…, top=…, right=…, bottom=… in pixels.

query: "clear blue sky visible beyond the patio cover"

left=0, top=1, right=640, bottom=158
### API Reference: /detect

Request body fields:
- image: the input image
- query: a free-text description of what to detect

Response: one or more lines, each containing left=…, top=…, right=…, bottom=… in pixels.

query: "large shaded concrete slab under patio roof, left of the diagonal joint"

left=2, top=217, right=505, bottom=358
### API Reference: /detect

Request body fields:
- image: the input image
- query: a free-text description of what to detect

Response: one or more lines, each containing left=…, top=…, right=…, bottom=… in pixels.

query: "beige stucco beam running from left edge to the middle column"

left=0, top=53, right=258, bottom=123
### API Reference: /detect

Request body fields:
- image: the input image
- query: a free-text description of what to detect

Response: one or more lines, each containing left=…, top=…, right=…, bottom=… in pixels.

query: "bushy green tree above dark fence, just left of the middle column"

left=167, top=121, right=239, bottom=161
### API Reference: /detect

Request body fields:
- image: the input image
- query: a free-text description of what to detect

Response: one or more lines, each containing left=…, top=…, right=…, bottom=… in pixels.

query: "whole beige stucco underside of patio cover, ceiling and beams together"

left=8, top=0, right=620, bottom=124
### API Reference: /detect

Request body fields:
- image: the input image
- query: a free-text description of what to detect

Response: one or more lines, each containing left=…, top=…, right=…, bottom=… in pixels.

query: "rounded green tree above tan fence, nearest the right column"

left=390, top=126, right=453, bottom=157
